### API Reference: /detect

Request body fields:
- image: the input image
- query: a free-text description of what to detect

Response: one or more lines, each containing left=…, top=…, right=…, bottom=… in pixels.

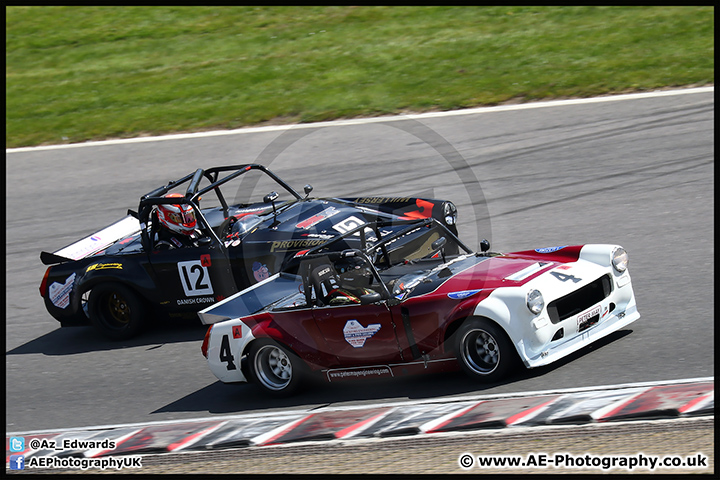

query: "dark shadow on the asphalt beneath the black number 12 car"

left=6, top=321, right=207, bottom=355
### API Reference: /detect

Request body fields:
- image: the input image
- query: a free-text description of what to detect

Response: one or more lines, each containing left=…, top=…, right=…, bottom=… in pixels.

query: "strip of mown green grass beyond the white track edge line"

left=5, top=6, right=715, bottom=148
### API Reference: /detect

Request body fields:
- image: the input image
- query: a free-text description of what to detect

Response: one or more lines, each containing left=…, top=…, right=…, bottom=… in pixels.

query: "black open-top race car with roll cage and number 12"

left=40, top=164, right=457, bottom=340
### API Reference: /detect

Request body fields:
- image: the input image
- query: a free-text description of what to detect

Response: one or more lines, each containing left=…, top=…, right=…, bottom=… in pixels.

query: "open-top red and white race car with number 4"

left=199, top=218, right=640, bottom=395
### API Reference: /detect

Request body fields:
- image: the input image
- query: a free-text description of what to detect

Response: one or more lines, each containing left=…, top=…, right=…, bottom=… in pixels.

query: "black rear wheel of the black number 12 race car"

left=88, top=283, right=145, bottom=340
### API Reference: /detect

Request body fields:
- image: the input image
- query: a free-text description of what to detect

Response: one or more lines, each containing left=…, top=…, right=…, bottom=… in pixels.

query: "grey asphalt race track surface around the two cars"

left=6, top=88, right=714, bottom=431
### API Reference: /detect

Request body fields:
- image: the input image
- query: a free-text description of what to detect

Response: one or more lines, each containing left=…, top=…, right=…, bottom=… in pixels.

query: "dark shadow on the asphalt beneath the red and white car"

left=152, top=330, right=632, bottom=414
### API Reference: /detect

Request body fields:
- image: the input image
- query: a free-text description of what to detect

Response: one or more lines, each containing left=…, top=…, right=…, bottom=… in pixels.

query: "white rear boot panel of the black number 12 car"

left=40, top=215, right=140, bottom=265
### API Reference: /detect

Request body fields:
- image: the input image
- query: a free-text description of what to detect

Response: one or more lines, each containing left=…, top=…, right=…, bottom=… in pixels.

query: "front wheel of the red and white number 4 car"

left=455, top=318, right=517, bottom=383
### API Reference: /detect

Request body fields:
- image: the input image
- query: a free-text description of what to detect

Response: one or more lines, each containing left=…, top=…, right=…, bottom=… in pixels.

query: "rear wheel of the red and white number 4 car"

left=247, top=339, right=306, bottom=397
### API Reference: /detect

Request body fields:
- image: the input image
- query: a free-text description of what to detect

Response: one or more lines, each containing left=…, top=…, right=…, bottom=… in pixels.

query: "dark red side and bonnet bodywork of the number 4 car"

left=225, top=246, right=582, bottom=373
